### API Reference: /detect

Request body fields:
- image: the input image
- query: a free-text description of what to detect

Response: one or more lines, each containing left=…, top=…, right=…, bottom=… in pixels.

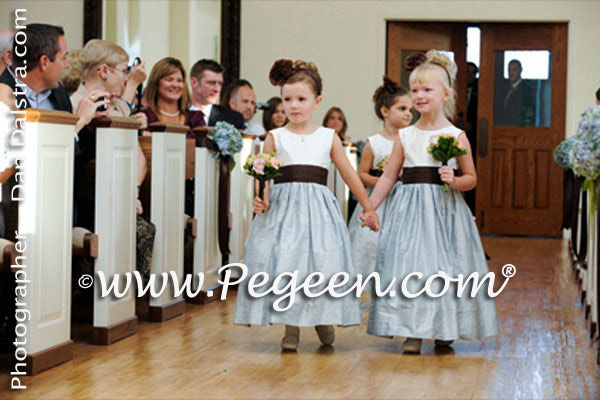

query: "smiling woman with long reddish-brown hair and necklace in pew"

left=142, top=57, right=206, bottom=138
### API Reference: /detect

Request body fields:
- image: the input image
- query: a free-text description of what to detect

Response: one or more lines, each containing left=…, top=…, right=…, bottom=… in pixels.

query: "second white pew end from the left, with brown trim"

left=90, top=117, right=141, bottom=345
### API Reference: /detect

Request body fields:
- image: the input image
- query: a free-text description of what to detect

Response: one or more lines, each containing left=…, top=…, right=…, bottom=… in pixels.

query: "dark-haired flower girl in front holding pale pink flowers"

left=234, top=60, right=379, bottom=350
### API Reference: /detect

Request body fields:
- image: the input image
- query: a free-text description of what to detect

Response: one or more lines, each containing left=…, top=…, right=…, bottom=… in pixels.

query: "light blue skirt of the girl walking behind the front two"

left=348, top=181, right=402, bottom=278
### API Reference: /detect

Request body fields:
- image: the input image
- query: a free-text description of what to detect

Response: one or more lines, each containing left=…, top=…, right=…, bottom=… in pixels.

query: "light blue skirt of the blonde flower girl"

left=367, top=183, right=504, bottom=340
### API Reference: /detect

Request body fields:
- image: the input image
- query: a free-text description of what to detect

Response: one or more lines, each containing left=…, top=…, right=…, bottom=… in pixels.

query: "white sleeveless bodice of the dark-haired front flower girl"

left=271, top=126, right=334, bottom=169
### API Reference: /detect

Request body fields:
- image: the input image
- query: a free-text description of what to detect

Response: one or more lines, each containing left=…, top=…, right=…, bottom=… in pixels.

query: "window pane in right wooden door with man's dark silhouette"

left=492, top=50, right=552, bottom=127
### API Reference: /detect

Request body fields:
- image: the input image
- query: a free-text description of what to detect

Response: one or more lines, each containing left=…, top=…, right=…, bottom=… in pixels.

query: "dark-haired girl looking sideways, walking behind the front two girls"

left=348, top=77, right=413, bottom=290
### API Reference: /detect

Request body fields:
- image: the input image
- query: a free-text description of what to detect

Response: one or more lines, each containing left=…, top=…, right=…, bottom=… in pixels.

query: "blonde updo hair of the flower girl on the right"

left=404, top=50, right=458, bottom=119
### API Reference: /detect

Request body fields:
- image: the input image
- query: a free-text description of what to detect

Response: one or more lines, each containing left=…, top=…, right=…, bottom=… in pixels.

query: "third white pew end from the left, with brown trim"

left=139, top=123, right=189, bottom=322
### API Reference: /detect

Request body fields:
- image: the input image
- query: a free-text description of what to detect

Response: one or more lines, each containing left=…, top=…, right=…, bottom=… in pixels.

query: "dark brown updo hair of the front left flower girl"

left=269, top=59, right=323, bottom=96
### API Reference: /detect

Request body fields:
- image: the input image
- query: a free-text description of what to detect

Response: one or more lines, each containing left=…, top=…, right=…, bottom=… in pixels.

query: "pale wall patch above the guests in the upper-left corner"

left=0, top=0, right=83, bottom=49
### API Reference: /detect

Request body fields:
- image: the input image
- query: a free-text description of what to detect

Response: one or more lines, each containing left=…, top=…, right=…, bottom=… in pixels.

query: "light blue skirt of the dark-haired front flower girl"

left=234, top=182, right=362, bottom=326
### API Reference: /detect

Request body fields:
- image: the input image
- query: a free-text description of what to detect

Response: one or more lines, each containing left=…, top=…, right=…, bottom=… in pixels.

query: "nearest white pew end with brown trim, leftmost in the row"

left=17, top=109, right=77, bottom=375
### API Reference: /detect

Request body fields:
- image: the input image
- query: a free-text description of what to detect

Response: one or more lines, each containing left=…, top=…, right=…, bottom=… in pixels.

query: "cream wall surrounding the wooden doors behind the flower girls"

left=241, top=0, right=600, bottom=139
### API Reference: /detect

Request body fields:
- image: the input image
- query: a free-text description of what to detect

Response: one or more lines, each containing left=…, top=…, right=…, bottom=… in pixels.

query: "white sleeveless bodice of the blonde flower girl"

left=400, top=125, right=462, bottom=169
